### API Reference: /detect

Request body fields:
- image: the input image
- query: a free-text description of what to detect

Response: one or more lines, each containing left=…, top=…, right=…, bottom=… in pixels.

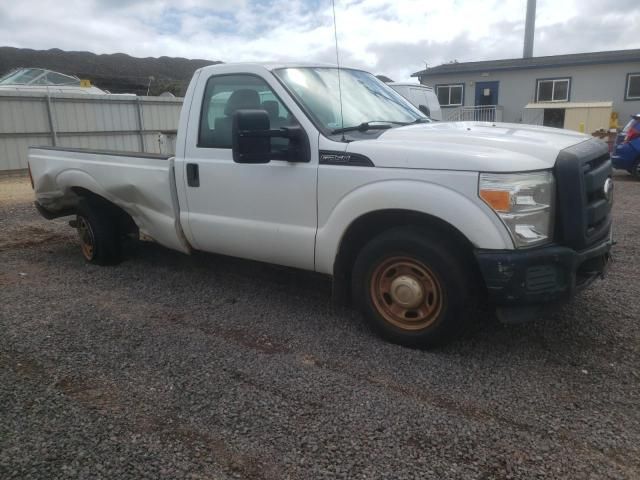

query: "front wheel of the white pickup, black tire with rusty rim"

left=352, top=227, right=475, bottom=347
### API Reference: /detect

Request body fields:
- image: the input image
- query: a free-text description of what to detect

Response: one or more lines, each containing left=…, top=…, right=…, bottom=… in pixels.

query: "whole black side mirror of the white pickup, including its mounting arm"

left=231, top=110, right=311, bottom=163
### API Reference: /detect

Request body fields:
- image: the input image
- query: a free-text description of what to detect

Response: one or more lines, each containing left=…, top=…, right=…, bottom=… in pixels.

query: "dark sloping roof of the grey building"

left=411, top=49, right=640, bottom=77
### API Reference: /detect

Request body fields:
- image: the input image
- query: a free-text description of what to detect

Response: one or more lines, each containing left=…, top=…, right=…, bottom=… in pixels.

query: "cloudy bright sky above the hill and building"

left=0, top=0, right=640, bottom=81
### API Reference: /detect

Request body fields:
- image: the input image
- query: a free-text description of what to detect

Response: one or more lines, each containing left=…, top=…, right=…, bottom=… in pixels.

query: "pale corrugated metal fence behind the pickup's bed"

left=0, top=92, right=182, bottom=171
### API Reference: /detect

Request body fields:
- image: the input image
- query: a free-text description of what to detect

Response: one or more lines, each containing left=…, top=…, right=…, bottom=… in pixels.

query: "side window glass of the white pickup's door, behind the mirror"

left=198, top=75, right=297, bottom=149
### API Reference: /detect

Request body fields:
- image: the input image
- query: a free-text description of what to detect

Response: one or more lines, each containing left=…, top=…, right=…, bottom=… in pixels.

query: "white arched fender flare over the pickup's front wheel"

left=316, top=180, right=513, bottom=274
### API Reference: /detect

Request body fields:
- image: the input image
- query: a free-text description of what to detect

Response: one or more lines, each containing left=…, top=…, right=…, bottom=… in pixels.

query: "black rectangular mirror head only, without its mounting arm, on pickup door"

left=231, top=110, right=271, bottom=163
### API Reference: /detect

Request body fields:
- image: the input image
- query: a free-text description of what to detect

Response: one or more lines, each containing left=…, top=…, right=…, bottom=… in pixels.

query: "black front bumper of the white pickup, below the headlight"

left=475, top=233, right=613, bottom=307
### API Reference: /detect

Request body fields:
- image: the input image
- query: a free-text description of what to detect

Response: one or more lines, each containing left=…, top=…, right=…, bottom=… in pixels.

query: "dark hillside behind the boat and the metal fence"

left=0, top=47, right=221, bottom=95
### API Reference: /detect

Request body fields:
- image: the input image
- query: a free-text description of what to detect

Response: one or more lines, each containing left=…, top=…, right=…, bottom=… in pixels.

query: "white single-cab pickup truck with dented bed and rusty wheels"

left=29, top=64, right=613, bottom=346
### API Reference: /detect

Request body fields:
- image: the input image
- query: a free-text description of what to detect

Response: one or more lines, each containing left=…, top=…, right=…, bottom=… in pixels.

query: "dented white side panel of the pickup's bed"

left=29, top=147, right=190, bottom=252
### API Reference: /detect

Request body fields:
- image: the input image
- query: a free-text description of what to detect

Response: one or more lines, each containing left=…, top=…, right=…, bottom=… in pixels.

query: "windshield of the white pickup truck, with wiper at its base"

left=275, top=67, right=428, bottom=131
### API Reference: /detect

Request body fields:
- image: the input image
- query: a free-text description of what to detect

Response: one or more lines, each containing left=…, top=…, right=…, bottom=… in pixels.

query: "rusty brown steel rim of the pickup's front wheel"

left=370, top=257, right=444, bottom=330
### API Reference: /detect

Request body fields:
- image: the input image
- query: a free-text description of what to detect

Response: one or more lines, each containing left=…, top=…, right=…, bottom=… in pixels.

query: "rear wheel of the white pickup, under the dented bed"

left=76, top=200, right=122, bottom=265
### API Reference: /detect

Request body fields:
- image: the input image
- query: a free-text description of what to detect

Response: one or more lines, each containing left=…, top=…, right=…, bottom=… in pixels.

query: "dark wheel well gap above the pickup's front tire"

left=333, top=210, right=482, bottom=304
